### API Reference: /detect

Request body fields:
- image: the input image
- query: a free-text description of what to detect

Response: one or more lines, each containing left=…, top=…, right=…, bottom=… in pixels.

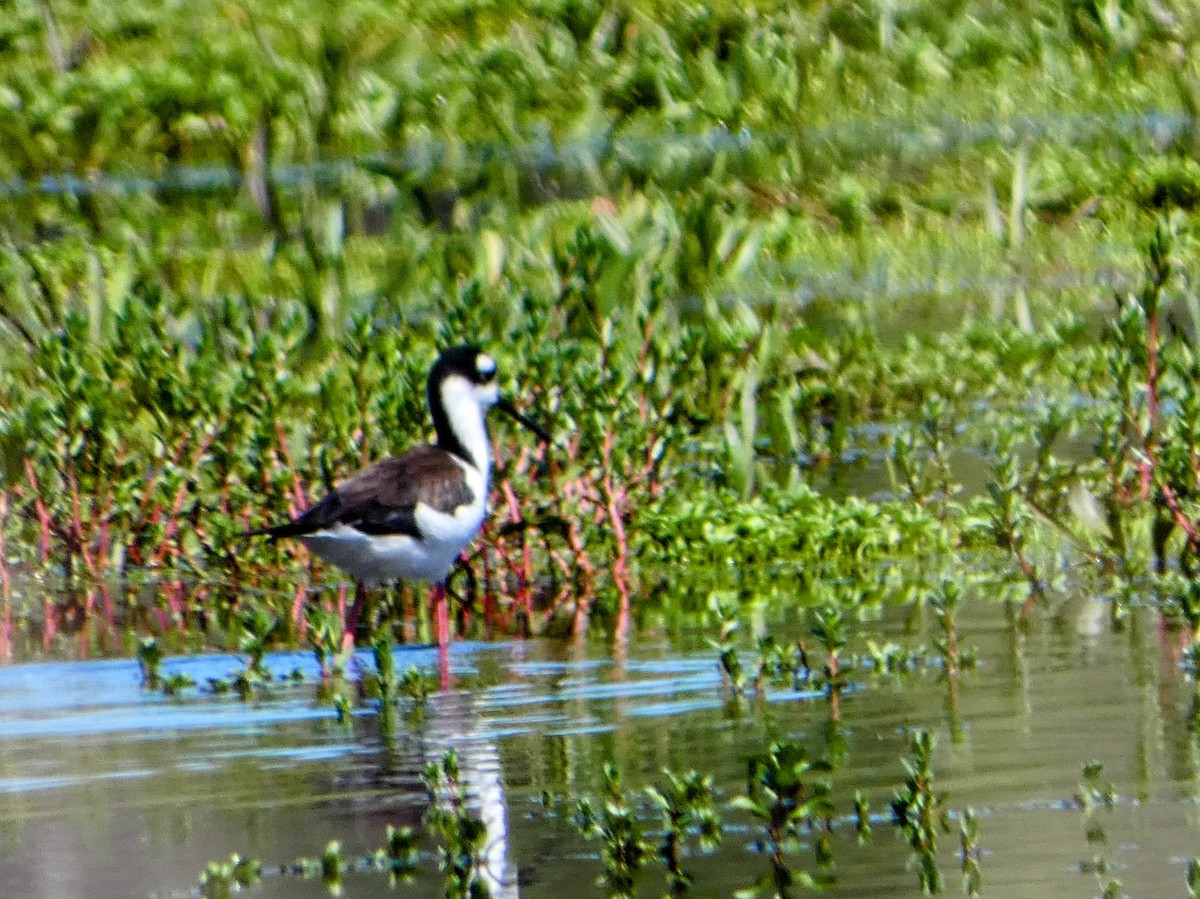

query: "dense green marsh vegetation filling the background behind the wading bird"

left=0, top=0, right=1200, bottom=643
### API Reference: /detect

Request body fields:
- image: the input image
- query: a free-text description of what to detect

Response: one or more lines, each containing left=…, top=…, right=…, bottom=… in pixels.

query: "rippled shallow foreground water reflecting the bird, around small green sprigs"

left=0, top=601, right=1200, bottom=899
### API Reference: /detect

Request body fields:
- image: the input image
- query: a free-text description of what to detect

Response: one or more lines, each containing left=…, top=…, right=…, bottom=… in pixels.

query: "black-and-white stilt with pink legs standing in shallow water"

left=252, top=346, right=550, bottom=648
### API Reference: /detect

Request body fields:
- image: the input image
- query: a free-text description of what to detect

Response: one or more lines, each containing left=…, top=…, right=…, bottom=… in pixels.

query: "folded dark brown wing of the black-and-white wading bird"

left=266, top=446, right=475, bottom=538
